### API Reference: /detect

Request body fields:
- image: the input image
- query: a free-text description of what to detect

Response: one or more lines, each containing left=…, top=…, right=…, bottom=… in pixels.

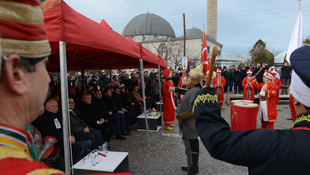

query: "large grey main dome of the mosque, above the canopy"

left=122, top=13, right=175, bottom=38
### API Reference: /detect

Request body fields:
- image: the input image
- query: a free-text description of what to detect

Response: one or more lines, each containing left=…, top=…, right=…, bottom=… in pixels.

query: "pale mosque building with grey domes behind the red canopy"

left=122, top=13, right=223, bottom=69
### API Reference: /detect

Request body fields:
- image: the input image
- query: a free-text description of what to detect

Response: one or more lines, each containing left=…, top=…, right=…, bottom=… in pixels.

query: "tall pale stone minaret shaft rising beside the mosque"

left=207, top=0, right=217, bottom=40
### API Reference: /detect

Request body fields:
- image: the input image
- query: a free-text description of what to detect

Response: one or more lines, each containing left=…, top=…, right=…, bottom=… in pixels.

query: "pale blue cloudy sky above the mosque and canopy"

left=65, top=0, right=310, bottom=55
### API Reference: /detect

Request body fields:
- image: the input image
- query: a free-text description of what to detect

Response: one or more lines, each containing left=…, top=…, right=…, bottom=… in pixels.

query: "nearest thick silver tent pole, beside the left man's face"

left=59, top=41, right=71, bottom=174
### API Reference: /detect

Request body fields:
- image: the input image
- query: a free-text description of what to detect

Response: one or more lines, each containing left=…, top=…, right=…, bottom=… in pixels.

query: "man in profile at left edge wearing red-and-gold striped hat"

left=0, top=0, right=62, bottom=174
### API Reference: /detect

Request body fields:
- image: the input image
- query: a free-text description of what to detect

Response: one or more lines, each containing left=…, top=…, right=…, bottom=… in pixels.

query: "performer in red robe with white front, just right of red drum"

left=258, top=70, right=278, bottom=129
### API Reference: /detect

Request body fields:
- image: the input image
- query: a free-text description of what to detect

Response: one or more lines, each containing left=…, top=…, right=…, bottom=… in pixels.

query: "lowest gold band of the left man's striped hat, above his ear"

left=1, top=39, right=51, bottom=58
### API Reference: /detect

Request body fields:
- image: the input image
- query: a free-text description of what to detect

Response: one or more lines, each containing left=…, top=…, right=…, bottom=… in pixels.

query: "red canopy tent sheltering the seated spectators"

left=43, top=1, right=167, bottom=71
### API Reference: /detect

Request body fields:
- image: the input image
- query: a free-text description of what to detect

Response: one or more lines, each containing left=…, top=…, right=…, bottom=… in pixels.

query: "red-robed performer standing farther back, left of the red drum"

left=213, top=69, right=226, bottom=108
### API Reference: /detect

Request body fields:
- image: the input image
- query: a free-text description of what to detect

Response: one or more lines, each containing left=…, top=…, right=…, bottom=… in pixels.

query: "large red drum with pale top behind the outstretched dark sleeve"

left=230, top=102, right=258, bottom=131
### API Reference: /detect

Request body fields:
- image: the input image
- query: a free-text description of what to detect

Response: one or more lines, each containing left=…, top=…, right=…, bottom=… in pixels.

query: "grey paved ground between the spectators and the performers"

left=110, top=92, right=292, bottom=175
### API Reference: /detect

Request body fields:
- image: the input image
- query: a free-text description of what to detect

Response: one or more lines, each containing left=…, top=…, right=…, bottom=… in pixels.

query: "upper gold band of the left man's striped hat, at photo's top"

left=0, top=1, right=43, bottom=24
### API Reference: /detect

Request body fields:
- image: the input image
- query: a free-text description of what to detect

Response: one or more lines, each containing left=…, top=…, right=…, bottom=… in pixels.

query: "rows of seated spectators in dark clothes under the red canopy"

left=31, top=70, right=165, bottom=169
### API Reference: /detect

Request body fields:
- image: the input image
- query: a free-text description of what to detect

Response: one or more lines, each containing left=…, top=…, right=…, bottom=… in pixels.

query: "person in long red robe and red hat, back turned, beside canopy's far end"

left=162, top=69, right=176, bottom=131
